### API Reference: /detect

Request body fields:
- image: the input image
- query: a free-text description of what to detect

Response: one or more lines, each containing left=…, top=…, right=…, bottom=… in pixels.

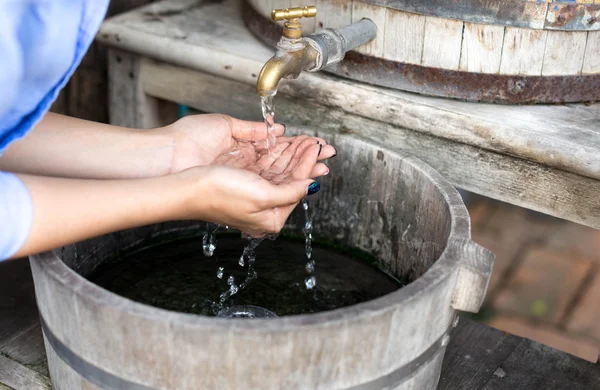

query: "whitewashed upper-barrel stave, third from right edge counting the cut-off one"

left=500, top=27, right=548, bottom=76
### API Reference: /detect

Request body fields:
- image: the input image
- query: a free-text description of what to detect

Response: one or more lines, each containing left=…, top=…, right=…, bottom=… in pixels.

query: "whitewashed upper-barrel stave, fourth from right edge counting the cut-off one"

left=459, top=23, right=505, bottom=73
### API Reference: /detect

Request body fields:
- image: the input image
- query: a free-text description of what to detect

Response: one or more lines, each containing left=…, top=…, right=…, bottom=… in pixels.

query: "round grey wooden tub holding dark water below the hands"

left=31, top=129, right=493, bottom=390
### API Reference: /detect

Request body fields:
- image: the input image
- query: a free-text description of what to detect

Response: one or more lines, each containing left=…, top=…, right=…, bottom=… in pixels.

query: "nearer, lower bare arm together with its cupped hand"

left=12, top=164, right=318, bottom=258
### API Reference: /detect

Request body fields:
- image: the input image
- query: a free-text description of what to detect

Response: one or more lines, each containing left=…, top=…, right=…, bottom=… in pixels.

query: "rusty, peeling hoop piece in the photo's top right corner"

left=544, top=4, right=600, bottom=31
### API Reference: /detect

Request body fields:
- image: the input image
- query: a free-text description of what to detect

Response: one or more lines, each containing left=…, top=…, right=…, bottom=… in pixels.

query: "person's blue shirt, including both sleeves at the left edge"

left=0, top=0, right=109, bottom=260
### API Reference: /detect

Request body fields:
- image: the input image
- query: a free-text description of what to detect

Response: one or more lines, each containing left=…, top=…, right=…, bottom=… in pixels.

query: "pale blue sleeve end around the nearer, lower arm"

left=0, top=172, right=33, bottom=261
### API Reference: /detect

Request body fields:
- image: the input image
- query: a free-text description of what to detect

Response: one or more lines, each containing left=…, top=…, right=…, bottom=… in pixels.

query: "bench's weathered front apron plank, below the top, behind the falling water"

left=144, top=63, right=600, bottom=228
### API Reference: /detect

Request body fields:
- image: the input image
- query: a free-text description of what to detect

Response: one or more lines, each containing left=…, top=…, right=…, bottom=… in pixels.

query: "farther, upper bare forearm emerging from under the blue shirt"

left=0, top=113, right=174, bottom=179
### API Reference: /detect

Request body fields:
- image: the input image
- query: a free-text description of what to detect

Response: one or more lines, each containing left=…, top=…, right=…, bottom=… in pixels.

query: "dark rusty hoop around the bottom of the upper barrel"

left=243, top=2, right=600, bottom=104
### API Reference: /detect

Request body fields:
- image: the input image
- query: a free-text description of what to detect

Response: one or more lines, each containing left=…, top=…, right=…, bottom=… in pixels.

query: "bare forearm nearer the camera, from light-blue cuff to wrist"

left=13, top=175, right=189, bottom=257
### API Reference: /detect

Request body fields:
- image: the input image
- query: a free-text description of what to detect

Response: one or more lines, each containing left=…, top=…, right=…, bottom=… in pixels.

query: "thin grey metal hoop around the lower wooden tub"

left=40, top=313, right=456, bottom=390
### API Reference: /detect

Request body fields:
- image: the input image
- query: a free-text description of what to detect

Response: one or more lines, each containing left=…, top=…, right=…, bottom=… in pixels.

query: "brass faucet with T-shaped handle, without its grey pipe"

left=256, top=6, right=318, bottom=96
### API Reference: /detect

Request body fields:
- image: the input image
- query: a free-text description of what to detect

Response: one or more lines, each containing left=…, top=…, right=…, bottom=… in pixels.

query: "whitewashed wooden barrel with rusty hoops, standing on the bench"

left=244, top=0, right=600, bottom=103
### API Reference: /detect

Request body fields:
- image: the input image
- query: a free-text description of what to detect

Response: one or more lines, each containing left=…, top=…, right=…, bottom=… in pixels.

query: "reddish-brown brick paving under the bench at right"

left=467, top=196, right=600, bottom=362
